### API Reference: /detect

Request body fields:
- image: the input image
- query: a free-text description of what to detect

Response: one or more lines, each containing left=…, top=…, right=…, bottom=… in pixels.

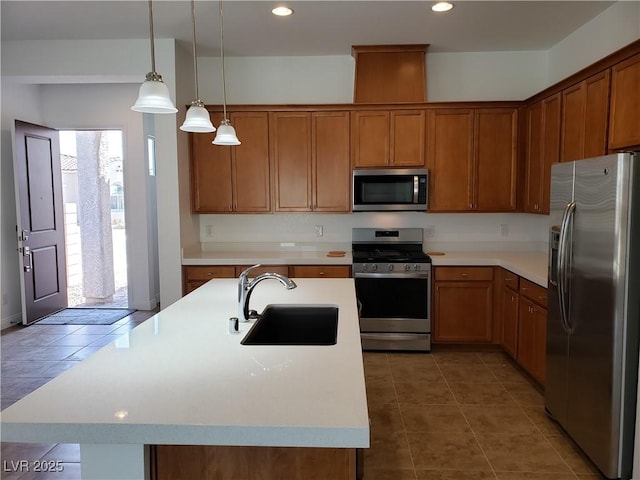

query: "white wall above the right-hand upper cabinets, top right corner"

left=547, top=1, right=640, bottom=85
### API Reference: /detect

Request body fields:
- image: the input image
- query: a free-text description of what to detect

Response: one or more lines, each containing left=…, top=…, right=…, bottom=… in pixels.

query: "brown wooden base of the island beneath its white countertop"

left=151, top=445, right=359, bottom=480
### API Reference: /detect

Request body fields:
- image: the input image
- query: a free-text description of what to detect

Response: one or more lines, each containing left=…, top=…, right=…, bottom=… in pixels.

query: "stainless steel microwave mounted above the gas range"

left=352, top=168, right=429, bottom=212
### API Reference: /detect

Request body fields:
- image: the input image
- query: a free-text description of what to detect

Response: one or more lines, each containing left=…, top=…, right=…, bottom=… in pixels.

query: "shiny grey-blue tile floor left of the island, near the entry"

left=0, top=310, right=155, bottom=480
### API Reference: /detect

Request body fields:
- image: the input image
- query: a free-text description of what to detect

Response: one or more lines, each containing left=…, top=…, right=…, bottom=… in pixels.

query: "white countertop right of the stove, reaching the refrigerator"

left=427, top=250, right=548, bottom=288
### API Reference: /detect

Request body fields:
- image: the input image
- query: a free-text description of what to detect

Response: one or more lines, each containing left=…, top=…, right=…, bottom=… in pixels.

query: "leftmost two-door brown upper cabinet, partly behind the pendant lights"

left=190, top=112, right=271, bottom=213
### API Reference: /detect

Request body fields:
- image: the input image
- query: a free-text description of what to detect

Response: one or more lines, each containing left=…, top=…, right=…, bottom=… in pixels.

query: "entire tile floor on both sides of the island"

left=0, top=312, right=602, bottom=480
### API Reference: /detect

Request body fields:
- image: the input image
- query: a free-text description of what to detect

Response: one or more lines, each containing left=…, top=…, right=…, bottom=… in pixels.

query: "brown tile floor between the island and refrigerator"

left=364, top=349, right=603, bottom=480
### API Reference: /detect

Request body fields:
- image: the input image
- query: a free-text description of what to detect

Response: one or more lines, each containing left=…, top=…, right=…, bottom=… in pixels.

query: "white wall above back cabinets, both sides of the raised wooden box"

left=198, top=51, right=547, bottom=104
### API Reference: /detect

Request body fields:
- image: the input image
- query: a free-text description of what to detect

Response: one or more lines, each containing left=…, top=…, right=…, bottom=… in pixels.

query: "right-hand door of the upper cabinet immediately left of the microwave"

left=311, top=112, right=351, bottom=212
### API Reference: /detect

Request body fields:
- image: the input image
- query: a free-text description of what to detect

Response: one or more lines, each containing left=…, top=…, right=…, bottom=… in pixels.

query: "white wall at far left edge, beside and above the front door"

left=0, top=78, right=43, bottom=328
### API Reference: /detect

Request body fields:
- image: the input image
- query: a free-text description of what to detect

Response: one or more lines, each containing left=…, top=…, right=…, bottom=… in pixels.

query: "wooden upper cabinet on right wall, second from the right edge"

left=560, top=70, right=610, bottom=162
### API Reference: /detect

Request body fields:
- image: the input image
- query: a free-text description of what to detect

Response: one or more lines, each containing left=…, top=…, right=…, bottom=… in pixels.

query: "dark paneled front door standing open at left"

left=14, top=120, right=67, bottom=325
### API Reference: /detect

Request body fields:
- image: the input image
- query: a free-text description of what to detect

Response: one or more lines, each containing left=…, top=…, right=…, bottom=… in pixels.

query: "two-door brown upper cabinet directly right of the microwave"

left=427, top=108, right=517, bottom=212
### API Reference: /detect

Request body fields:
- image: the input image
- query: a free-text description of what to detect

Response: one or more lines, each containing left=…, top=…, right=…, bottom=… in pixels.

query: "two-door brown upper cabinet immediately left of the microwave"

left=269, top=111, right=351, bottom=212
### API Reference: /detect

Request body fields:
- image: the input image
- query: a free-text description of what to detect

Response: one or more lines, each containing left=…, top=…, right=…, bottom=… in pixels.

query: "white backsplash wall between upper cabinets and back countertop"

left=200, top=212, right=548, bottom=251
